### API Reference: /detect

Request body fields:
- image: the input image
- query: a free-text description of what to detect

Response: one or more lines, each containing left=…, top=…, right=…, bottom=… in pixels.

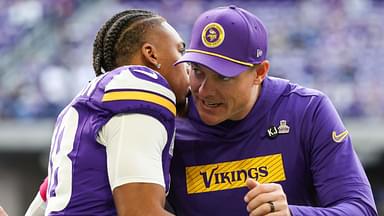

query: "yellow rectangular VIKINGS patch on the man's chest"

left=185, top=154, right=286, bottom=194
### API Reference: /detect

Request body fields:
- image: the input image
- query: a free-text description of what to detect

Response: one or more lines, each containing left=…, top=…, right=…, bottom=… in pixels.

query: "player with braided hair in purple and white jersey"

left=26, top=10, right=188, bottom=215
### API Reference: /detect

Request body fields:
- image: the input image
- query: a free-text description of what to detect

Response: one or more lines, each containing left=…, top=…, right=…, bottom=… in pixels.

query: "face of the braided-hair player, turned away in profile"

left=152, top=22, right=189, bottom=104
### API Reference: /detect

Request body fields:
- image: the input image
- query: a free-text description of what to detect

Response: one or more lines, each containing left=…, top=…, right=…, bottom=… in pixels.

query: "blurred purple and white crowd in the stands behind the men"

left=0, top=0, right=384, bottom=120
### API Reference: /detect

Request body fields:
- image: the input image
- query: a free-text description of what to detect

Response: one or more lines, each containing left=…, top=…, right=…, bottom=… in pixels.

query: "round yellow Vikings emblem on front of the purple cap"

left=201, top=23, right=225, bottom=48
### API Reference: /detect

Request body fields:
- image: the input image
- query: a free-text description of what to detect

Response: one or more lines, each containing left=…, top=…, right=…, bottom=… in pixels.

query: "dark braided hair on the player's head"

left=93, top=9, right=165, bottom=76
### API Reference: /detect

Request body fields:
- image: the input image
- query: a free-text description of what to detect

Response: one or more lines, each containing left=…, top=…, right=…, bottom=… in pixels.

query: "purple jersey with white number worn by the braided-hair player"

left=47, top=66, right=176, bottom=215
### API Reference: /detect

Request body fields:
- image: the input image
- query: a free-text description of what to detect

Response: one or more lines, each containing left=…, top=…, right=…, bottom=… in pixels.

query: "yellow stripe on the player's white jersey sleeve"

left=102, top=91, right=176, bottom=116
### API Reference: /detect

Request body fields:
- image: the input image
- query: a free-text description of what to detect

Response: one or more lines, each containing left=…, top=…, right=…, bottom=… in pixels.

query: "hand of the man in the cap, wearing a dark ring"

left=244, top=179, right=291, bottom=216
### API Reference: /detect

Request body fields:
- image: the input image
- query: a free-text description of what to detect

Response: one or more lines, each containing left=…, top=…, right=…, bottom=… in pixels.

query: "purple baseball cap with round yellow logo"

left=176, top=5, right=268, bottom=77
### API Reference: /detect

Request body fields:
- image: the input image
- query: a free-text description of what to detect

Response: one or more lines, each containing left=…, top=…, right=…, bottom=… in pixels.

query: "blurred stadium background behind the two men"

left=0, top=0, right=384, bottom=215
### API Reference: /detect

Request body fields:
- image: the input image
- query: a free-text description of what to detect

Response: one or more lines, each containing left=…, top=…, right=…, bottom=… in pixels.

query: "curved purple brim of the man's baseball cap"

left=175, top=52, right=249, bottom=77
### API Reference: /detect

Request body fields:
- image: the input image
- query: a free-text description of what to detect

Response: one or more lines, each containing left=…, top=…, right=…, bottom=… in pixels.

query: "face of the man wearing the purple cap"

left=190, top=63, right=258, bottom=125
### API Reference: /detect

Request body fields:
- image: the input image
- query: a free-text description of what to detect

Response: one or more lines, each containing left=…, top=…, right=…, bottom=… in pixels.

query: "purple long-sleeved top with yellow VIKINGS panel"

left=168, top=77, right=375, bottom=216
